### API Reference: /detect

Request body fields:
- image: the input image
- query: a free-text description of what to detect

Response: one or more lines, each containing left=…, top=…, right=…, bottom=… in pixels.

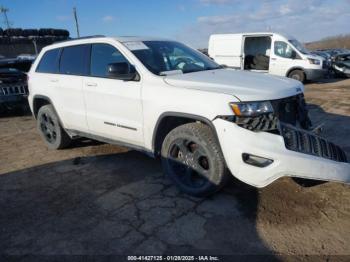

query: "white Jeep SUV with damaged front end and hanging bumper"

left=29, top=37, right=350, bottom=196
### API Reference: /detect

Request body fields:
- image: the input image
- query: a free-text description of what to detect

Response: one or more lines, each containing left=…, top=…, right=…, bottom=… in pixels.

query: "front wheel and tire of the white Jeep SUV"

left=161, top=123, right=228, bottom=197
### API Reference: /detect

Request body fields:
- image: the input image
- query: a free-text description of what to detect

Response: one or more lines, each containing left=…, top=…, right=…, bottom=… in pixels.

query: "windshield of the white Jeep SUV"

left=124, top=41, right=220, bottom=75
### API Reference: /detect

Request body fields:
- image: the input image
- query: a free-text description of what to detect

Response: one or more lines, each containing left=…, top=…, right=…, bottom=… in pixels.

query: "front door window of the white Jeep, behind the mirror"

left=90, top=44, right=129, bottom=77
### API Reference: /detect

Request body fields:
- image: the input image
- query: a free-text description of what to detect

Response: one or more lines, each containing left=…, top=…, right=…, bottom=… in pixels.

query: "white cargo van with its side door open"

left=208, top=33, right=327, bottom=82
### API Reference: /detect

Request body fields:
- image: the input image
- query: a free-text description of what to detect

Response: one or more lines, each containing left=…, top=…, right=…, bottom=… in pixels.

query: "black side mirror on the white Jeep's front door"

left=107, top=62, right=138, bottom=81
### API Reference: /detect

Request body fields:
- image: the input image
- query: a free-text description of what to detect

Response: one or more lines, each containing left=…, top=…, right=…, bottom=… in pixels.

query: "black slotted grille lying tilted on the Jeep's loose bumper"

left=280, top=122, right=347, bottom=162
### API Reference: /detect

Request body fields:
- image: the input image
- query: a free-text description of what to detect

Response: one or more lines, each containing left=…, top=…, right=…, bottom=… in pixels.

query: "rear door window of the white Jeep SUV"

left=60, top=45, right=90, bottom=75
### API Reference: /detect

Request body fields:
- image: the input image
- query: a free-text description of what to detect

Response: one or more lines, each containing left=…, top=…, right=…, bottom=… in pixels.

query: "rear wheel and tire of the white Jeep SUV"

left=37, top=105, right=71, bottom=149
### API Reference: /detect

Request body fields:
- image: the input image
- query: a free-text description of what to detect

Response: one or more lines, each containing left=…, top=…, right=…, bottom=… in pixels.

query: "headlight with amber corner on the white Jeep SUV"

left=230, top=101, right=273, bottom=116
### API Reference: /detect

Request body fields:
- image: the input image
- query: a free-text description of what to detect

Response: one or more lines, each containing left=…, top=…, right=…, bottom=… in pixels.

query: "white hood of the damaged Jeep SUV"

left=164, top=69, right=304, bottom=101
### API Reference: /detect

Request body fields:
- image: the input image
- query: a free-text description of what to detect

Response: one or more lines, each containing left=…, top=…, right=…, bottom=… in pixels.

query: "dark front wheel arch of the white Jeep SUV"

left=152, top=112, right=221, bottom=157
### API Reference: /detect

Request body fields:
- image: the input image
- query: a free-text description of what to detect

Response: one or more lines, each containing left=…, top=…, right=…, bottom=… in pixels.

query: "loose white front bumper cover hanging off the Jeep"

left=213, top=119, right=350, bottom=187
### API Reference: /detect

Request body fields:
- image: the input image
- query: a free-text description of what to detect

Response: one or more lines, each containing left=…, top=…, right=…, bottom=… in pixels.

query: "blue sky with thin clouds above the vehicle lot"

left=0, top=0, right=350, bottom=47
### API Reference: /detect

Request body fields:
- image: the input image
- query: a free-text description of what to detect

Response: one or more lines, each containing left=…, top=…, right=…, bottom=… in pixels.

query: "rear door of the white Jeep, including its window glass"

left=51, top=45, right=90, bottom=132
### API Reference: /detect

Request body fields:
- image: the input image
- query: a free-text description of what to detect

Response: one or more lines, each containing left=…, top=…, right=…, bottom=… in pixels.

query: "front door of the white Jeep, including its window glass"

left=83, top=43, right=143, bottom=146
